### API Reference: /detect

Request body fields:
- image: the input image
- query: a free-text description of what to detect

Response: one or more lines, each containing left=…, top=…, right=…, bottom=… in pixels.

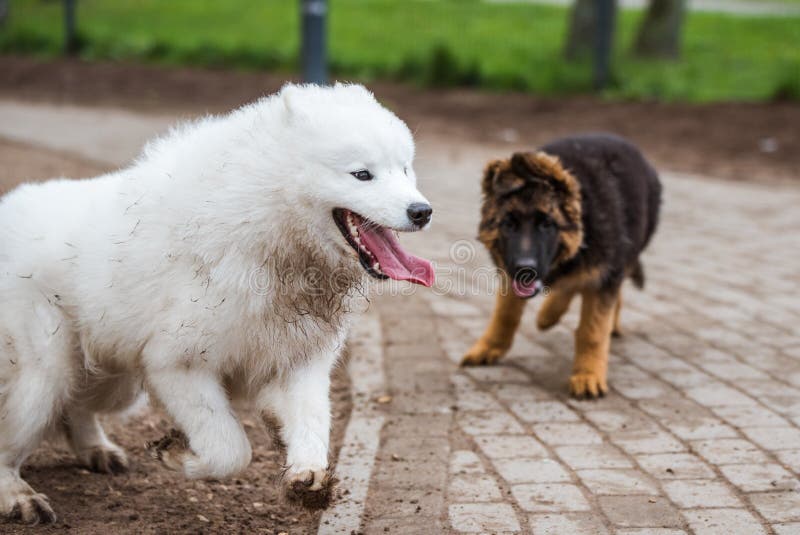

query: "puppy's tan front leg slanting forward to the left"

left=461, top=290, right=525, bottom=366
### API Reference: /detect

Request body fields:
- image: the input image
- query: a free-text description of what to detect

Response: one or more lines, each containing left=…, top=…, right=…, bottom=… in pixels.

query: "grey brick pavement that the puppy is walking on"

left=0, top=100, right=800, bottom=535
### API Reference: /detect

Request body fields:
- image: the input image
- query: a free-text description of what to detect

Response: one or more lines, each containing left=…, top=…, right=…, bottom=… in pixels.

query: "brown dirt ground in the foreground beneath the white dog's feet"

left=0, top=360, right=350, bottom=535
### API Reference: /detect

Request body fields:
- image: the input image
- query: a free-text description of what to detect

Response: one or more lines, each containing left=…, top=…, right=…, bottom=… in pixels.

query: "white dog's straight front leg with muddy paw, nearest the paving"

left=259, top=355, right=336, bottom=508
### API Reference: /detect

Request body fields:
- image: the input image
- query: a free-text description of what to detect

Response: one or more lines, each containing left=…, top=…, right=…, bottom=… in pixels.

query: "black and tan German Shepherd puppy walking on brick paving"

left=462, top=134, right=661, bottom=398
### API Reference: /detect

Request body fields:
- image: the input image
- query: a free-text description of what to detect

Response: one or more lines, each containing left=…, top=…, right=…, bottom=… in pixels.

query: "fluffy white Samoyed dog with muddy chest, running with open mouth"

left=0, top=84, right=434, bottom=522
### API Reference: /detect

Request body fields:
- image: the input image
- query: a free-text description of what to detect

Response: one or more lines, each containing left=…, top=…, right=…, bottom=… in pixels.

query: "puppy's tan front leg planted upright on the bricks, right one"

left=569, top=289, right=617, bottom=398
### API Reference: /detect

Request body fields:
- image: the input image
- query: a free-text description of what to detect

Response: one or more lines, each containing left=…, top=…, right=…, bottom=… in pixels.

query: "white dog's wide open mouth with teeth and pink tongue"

left=333, top=208, right=435, bottom=287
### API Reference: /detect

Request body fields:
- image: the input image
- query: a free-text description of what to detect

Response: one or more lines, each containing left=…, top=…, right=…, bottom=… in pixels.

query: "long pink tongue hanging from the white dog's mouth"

left=358, top=225, right=436, bottom=287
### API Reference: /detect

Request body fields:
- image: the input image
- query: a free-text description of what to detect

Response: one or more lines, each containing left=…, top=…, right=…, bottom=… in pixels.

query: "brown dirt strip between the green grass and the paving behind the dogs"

left=0, top=56, right=800, bottom=181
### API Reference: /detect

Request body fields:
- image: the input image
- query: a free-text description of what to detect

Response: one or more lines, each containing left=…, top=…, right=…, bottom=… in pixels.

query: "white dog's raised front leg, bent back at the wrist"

left=149, top=369, right=252, bottom=478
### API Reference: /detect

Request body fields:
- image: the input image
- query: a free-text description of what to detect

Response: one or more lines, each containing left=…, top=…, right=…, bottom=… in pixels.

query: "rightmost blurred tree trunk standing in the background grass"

left=633, top=0, right=686, bottom=58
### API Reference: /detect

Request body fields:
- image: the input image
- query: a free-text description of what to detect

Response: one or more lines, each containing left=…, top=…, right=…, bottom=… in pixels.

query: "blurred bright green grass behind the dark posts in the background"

left=0, top=0, right=800, bottom=102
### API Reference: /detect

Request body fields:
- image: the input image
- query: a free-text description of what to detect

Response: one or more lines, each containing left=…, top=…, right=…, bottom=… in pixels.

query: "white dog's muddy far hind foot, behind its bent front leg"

left=65, top=407, right=128, bottom=474
